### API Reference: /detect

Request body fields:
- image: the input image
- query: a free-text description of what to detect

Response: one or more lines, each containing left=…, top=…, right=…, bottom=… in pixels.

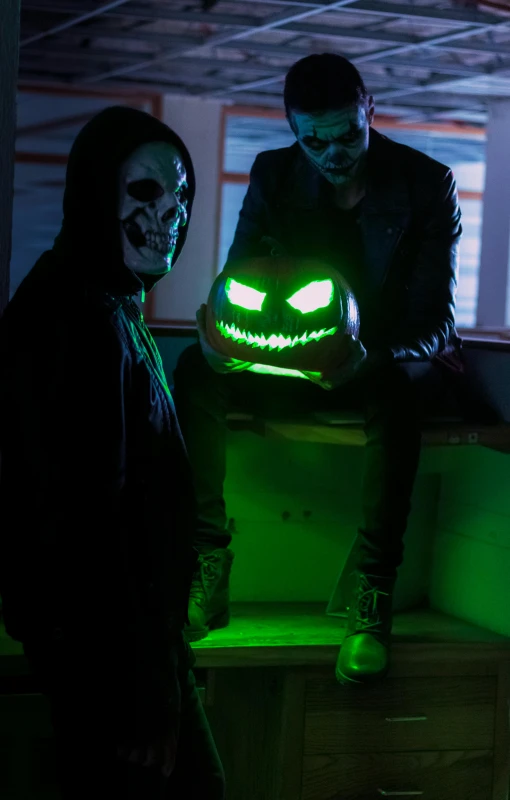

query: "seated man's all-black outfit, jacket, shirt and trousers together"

left=174, top=129, right=463, bottom=577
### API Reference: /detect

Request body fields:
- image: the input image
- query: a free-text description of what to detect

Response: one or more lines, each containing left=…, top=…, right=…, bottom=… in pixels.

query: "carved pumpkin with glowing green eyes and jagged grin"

left=206, top=257, right=359, bottom=372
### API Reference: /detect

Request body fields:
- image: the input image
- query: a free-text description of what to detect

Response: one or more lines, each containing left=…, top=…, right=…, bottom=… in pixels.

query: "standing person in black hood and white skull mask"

left=0, top=107, right=225, bottom=800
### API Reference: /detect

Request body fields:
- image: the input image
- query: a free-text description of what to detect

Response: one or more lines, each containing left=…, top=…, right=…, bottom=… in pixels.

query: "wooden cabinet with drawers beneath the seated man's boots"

left=0, top=604, right=510, bottom=800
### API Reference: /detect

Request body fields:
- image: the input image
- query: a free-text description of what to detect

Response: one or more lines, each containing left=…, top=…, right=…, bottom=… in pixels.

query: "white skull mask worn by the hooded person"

left=117, top=142, right=188, bottom=275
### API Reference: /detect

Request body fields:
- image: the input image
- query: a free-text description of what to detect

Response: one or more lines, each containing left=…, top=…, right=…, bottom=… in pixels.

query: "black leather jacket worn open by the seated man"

left=228, top=128, right=462, bottom=369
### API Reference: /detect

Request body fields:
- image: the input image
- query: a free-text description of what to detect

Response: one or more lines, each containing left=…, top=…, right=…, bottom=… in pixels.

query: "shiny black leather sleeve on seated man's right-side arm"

left=382, top=171, right=462, bottom=361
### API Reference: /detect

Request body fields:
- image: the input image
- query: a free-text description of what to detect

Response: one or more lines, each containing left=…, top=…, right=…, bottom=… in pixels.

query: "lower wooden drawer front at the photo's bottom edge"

left=301, top=750, right=492, bottom=800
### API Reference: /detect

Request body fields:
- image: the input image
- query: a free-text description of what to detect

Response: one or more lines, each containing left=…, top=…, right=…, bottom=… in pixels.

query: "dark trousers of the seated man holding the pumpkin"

left=173, top=344, right=456, bottom=577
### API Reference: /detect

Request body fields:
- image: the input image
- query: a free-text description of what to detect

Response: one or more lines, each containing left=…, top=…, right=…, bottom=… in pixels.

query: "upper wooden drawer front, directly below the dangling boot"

left=304, top=677, right=497, bottom=755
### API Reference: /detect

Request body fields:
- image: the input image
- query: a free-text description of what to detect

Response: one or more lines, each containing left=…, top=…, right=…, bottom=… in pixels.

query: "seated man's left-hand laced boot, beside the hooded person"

left=184, top=547, right=234, bottom=642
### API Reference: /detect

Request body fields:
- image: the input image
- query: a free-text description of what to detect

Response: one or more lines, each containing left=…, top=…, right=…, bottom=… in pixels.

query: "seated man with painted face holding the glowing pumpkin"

left=174, top=54, right=478, bottom=684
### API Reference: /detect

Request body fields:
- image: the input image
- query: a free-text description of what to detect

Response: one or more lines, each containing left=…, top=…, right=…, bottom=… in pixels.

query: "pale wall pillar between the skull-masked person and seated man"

left=153, top=96, right=222, bottom=320
